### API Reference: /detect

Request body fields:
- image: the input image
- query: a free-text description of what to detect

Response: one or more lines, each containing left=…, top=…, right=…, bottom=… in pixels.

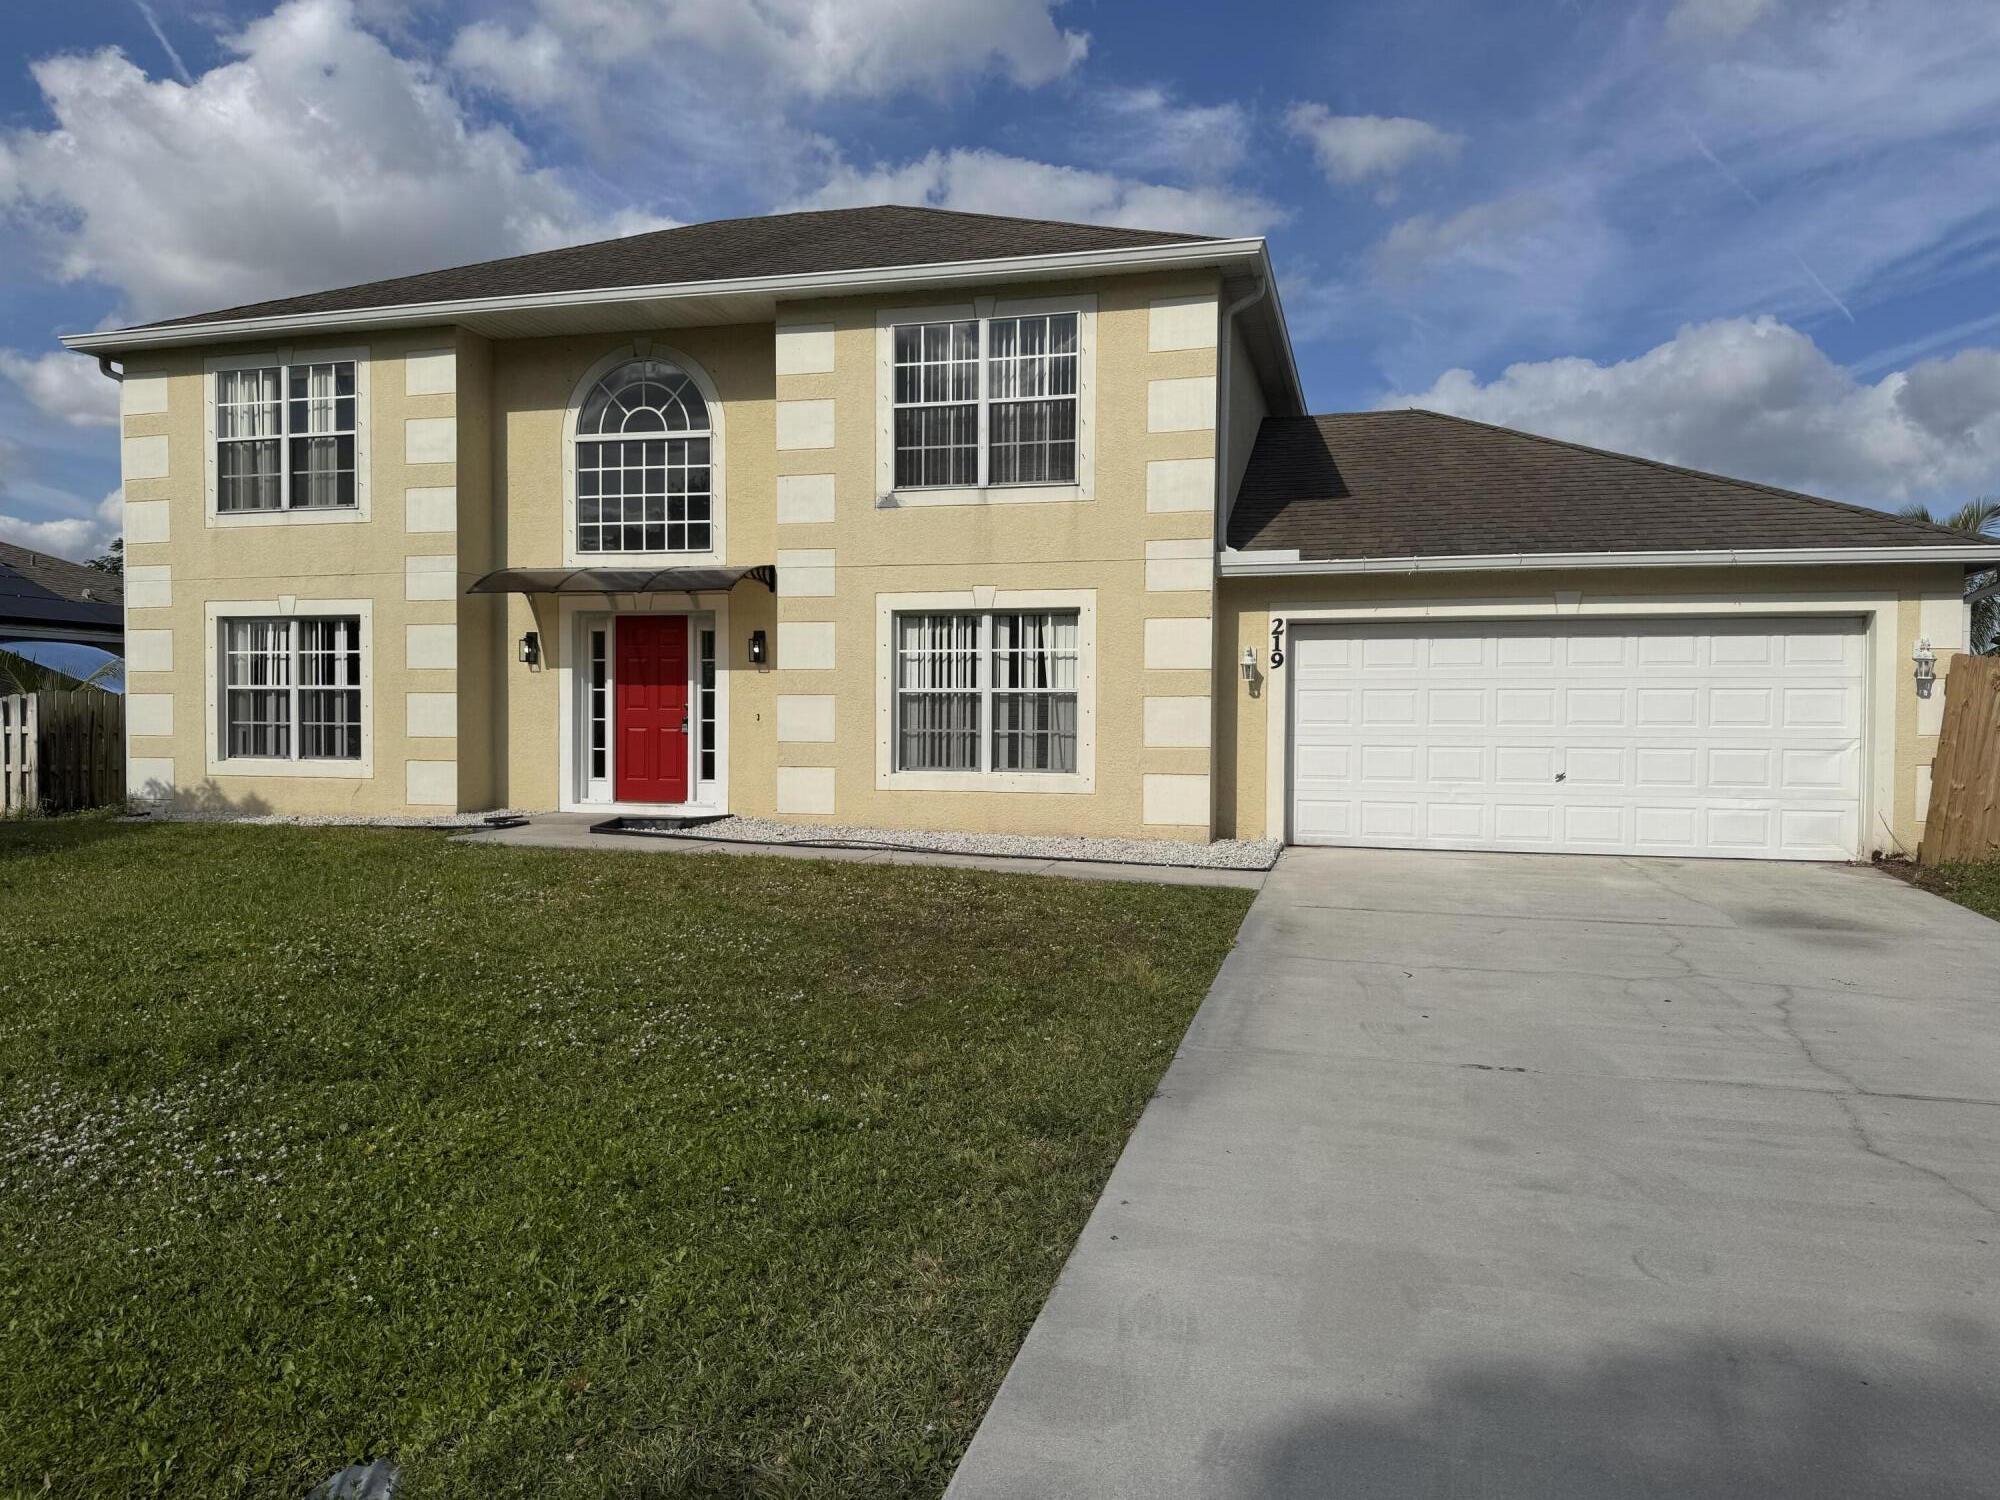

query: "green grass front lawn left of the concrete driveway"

left=0, top=820, right=1248, bottom=1500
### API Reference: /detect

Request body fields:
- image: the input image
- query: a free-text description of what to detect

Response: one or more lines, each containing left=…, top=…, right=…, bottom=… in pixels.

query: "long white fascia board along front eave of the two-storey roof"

left=62, top=236, right=1270, bottom=354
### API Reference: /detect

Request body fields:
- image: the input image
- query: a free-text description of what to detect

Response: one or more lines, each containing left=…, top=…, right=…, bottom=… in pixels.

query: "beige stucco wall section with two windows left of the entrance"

left=122, top=330, right=466, bottom=814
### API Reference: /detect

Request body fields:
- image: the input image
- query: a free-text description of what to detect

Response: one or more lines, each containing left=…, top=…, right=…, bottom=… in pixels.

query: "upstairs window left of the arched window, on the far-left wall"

left=214, top=360, right=358, bottom=514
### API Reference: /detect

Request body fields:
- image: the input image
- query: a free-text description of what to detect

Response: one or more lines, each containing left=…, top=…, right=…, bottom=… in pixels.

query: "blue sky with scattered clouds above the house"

left=0, top=0, right=2000, bottom=556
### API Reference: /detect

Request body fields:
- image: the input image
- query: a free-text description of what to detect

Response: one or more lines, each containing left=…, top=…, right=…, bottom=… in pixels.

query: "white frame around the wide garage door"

left=1264, top=590, right=1898, bottom=858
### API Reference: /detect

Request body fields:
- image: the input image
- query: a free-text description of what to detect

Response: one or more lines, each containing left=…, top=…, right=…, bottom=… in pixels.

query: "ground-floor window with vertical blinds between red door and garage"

left=896, top=610, right=1078, bottom=774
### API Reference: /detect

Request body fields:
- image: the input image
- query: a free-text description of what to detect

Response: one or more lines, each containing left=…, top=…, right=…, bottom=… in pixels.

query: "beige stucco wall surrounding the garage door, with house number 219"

left=1216, top=566, right=1966, bottom=852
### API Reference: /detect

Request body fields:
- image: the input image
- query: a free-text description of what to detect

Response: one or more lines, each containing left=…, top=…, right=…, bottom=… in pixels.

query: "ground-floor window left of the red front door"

left=222, top=614, right=362, bottom=760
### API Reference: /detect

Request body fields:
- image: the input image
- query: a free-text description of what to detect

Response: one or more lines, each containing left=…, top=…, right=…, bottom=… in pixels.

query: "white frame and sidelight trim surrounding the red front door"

left=554, top=592, right=734, bottom=818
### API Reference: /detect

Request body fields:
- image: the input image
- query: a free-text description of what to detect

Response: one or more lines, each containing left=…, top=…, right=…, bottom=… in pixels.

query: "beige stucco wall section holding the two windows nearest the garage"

left=760, top=264, right=1218, bottom=840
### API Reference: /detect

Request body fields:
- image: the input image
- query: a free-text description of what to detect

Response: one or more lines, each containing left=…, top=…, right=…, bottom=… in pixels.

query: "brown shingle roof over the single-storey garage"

left=1228, top=410, right=1972, bottom=560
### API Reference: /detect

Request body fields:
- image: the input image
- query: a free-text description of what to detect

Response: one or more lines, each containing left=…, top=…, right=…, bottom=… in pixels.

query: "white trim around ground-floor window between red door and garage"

left=876, top=588, right=1098, bottom=796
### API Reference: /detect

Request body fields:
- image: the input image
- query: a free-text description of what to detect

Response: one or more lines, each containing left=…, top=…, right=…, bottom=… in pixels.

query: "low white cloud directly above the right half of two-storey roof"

left=796, top=150, right=1282, bottom=236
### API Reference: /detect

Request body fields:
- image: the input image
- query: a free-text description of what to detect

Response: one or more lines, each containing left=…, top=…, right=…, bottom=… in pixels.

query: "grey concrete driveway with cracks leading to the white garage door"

left=950, top=850, right=2000, bottom=1500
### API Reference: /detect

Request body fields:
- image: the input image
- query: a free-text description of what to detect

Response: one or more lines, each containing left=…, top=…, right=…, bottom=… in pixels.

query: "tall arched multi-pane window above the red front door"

left=576, top=360, right=714, bottom=554
